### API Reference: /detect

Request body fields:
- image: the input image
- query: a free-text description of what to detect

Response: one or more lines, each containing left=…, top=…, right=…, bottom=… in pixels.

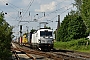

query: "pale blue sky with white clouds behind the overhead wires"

left=0, top=0, right=75, bottom=36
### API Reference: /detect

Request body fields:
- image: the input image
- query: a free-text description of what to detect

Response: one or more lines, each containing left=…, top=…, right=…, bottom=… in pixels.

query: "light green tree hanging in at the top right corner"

left=74, top=0, right=90, bottom=33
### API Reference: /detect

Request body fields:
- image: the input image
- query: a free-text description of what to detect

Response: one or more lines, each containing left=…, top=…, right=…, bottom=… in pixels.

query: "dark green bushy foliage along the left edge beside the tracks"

left=0, top=12, right=12, bottom=60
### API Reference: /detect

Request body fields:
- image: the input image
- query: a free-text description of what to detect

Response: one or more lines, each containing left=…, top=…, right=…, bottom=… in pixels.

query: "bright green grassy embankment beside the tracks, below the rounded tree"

left=54, top=38, right=90, bottom=53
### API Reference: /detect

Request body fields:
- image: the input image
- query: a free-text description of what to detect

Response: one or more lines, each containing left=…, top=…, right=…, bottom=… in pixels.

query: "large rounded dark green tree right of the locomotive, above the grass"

left=57, top=12, right=87, bottom=41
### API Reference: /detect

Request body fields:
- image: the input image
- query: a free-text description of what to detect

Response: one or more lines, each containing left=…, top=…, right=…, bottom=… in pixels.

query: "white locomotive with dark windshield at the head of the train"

left=28, top=28, right=54, bottom=50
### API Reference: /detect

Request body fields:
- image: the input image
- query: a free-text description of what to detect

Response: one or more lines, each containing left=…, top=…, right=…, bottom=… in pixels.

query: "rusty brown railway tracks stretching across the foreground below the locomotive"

left=12, top=44, right=90, bottom=60
